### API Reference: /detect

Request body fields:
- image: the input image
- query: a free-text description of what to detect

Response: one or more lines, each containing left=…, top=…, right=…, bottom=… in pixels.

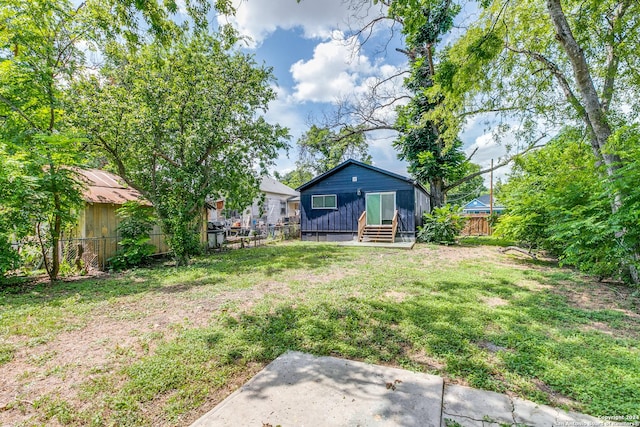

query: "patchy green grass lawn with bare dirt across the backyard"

left=0, top=242, right=640, bottom=425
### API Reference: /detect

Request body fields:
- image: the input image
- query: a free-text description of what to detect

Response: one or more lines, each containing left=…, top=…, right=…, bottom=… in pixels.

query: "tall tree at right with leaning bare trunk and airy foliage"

left=437, top=0, right=640, bottom=282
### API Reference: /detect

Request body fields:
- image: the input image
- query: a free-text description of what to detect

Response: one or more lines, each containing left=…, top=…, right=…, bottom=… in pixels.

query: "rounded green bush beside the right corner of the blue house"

left=417, top=205, right=467, bottom=245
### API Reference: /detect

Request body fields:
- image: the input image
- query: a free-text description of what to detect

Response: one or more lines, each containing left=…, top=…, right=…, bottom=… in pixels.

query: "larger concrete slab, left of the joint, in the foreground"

left=193, top=352, right=444, bottom=427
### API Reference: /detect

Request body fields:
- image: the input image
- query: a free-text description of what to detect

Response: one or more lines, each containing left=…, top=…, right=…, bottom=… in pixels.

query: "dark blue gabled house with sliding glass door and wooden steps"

left=297, top=159, right=429, bottom=242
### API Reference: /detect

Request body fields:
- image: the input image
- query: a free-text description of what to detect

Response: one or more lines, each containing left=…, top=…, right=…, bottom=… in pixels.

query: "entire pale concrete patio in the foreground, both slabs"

left=192, top=352, right=612, bottom=427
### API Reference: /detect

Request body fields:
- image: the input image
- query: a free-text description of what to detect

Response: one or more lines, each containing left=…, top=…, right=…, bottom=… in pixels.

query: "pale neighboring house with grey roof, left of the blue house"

left=209, top=176, right=300, bottom=228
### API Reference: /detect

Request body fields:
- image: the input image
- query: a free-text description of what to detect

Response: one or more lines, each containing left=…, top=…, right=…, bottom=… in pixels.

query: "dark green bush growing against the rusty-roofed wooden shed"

left=109, top=202, right=156, bottom=270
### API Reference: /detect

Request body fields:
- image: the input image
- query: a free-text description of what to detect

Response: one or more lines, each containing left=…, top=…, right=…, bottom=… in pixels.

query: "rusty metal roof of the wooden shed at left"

left=76, top=169, right=151, bottom=206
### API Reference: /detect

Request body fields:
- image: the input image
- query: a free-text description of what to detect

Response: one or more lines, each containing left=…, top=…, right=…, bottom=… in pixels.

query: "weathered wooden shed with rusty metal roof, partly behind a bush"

left=66, top=169, right=169, bottom=268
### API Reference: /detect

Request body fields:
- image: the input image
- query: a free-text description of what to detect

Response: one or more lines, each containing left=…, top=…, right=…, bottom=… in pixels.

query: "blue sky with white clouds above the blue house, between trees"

left=212, top=0, right=507, bottom=184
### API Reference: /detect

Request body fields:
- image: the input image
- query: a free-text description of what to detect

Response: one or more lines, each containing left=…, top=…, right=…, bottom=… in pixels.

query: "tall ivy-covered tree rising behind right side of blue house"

left=294, top=0, right=512, bottom=208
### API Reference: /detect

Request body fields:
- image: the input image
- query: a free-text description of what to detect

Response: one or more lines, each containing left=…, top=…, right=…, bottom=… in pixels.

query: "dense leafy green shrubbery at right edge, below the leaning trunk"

left=496, top=128, right=640, bottom=278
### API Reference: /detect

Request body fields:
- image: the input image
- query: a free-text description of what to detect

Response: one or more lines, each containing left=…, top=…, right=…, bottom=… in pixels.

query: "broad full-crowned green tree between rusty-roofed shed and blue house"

left=73, top=35, right=287, bottom=264
